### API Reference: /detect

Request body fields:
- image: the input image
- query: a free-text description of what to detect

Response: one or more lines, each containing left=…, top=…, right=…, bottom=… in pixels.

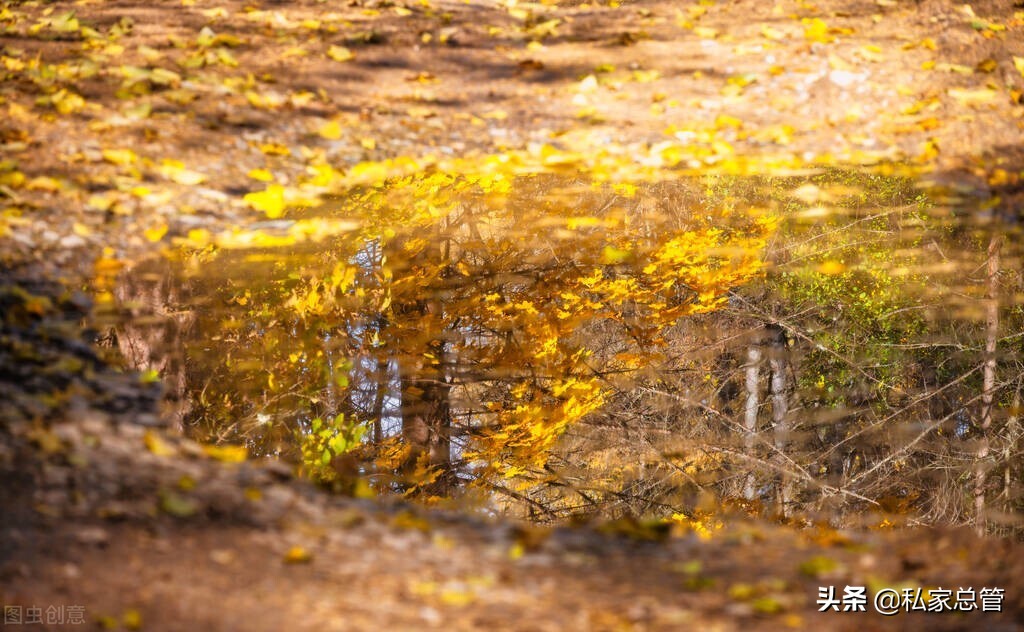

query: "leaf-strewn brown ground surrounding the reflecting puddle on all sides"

left=0, top=0, right=1024, bottom=630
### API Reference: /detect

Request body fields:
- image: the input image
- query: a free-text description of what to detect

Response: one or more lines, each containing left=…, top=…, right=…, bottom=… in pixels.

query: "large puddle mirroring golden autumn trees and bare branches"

left=99, top=170, right=1024, bottom=529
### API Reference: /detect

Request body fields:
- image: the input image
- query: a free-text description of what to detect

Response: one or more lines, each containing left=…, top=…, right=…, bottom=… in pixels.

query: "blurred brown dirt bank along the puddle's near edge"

left=0, top=418, right=1024, bottom=631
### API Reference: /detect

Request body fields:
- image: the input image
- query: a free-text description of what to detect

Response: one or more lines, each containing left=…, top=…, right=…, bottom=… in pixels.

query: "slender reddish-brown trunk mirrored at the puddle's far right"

left=974, top=235, right=1001, bottom=536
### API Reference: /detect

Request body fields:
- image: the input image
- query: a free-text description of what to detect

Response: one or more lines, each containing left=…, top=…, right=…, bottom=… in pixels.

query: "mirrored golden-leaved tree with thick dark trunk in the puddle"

left=161, top=172, right=773, bottom=502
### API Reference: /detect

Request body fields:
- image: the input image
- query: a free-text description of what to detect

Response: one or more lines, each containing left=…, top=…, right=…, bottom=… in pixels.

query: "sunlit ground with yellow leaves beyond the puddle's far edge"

left=0, top=0, right=1024, bottom=267
